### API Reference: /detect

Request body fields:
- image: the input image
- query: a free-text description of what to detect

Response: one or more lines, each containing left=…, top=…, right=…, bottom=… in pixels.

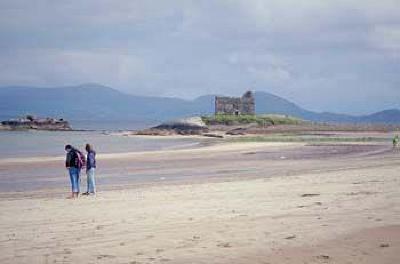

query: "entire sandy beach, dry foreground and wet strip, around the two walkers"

left=0, top=139, right=400, bottom=264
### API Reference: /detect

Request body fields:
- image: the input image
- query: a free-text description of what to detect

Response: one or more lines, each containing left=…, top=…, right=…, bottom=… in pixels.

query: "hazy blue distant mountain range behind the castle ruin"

left=0, top=84, right=400, bottom=124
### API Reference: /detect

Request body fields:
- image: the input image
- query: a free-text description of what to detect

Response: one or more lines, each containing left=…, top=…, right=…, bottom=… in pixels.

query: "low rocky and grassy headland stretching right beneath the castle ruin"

left=129, top=114, right=400, bottom=143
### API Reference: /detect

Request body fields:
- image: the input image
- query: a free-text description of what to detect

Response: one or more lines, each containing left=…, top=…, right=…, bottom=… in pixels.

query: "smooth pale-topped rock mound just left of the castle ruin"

left=135, top=117, right=209, bottom=136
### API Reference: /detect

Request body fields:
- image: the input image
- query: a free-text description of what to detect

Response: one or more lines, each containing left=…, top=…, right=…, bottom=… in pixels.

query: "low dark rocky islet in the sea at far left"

left=0, top=115, right=71, bottom=130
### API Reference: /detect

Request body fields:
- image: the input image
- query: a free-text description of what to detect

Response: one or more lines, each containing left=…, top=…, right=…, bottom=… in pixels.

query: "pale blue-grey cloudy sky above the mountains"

left=0, top=0, right=400, bottom=114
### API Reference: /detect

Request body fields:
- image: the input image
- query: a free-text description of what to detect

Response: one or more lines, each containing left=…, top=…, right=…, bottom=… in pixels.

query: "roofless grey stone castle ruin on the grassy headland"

left=215, top=91, right=255, bottom=115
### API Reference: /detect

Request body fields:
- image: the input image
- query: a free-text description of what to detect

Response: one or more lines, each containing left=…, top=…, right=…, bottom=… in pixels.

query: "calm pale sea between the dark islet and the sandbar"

left=0, top=120, right=199, bottom=159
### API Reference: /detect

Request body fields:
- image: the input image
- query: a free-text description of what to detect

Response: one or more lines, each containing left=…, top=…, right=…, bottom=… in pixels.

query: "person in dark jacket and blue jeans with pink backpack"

left=65, top=145, right=85, bottom=199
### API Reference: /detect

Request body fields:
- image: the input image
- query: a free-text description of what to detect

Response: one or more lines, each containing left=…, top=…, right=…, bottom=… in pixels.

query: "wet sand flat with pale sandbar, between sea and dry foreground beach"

left=0, top=139, right=398, bottom=192
